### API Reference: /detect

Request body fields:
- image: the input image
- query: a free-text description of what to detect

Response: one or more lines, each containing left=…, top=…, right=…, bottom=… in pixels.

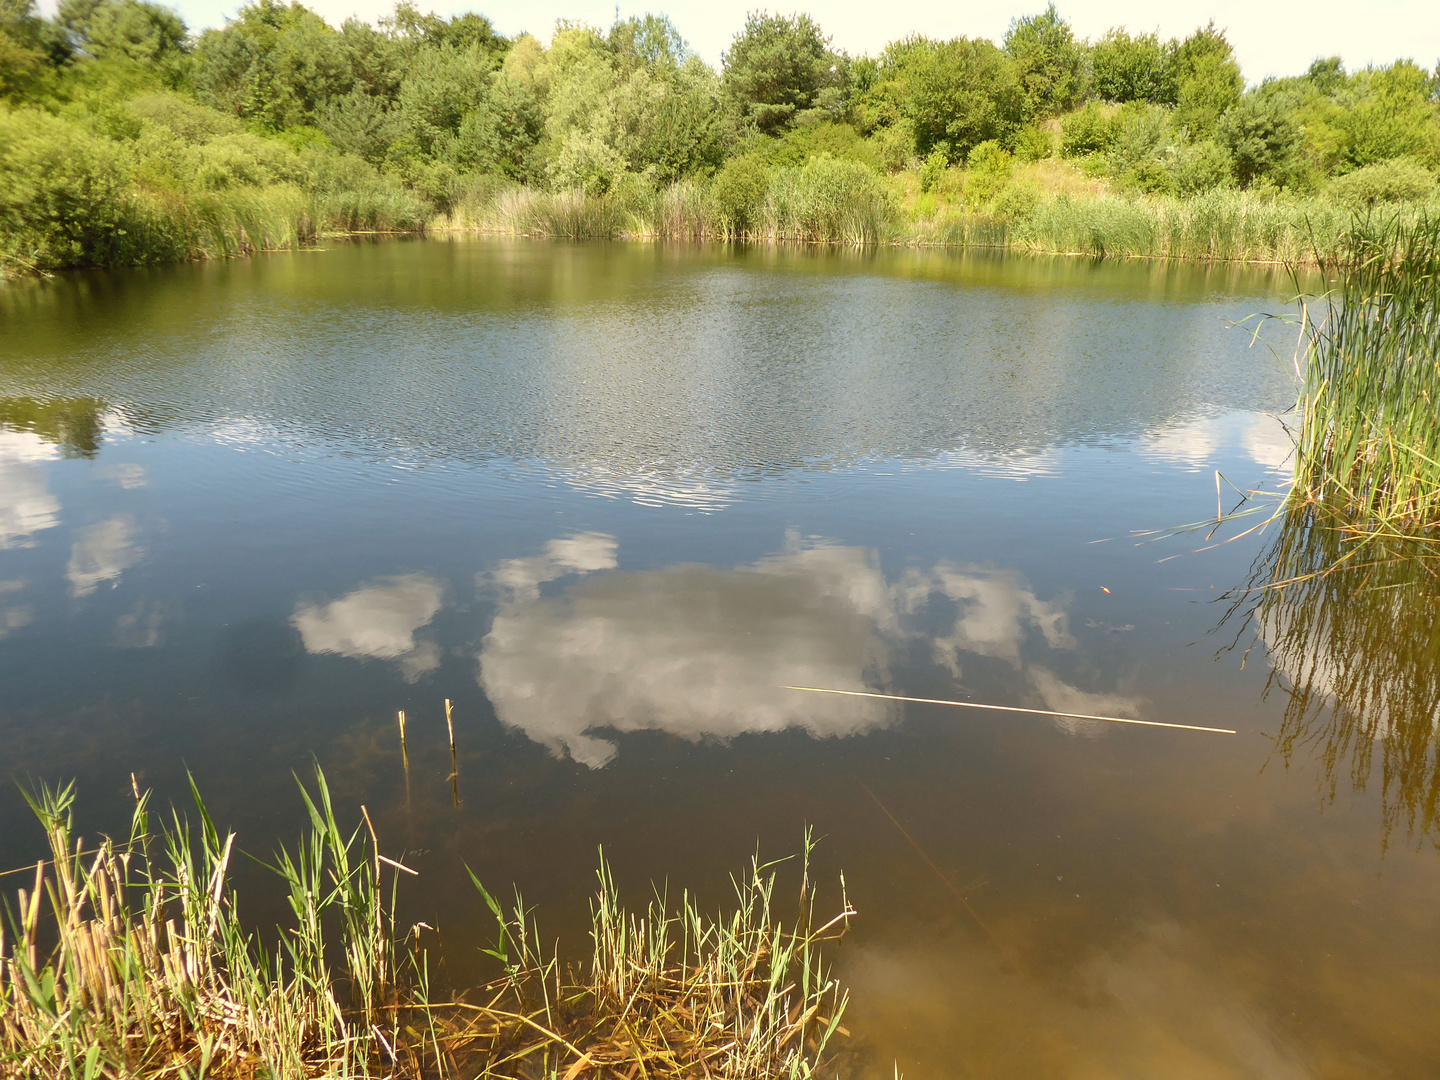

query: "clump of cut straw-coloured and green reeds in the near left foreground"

left=0, top=770, right=854, bottom=1080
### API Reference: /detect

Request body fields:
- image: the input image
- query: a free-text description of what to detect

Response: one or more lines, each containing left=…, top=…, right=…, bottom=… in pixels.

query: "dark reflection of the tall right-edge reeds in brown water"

left=1225, top=505, right=1440, bottom=842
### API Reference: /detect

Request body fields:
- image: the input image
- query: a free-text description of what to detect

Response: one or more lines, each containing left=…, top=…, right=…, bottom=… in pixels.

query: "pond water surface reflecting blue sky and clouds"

left=0, top=240, right=1440, bottom=1079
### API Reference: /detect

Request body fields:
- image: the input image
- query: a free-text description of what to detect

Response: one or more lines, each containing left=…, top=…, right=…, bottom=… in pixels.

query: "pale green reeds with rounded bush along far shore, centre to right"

left=433, top=176, right=1440, bottom=266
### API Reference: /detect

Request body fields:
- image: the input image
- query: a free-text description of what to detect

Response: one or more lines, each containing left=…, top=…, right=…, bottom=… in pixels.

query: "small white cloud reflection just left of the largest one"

left=291, top=573, right=445, bottom=681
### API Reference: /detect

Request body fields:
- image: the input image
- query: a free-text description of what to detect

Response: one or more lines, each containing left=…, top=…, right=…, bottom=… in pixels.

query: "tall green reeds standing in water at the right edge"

left=1295, top=213, right=1440, bottom=531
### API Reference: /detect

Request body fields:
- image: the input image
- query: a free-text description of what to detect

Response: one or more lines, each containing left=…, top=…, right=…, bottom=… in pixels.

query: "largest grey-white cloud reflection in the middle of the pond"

left=478, top=533, right=1135, bottom=768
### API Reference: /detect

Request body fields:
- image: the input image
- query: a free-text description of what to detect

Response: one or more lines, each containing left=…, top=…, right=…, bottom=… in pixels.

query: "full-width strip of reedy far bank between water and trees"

left=11, top=178, right=1440, bottom=276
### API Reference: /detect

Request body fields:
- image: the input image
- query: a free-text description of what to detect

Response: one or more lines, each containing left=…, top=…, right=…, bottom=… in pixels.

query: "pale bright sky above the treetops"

left=149, top=0, right=1440, bottom=82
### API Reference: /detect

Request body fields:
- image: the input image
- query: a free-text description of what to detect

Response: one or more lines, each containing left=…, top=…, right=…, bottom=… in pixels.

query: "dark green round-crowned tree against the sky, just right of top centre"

left=723, top=13, right=844, bottom=132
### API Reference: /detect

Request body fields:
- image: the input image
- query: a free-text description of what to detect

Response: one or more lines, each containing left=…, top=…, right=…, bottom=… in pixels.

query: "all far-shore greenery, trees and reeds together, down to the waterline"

left=0, top=0, right=1440, bottom=276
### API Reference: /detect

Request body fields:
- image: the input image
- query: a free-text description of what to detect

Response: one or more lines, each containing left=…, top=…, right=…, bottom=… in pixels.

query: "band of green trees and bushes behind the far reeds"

left=0, top=0, right=1440, bottom=269
